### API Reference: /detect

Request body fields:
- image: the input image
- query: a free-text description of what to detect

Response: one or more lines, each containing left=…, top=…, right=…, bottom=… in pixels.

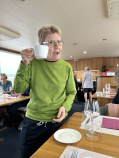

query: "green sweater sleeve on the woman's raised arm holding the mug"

left=14, top=62, right=31, bottom=93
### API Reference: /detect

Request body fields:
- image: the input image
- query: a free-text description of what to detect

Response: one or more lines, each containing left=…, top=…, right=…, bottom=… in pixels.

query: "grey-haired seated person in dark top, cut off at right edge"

left=100, top=69, right=119, bottom=115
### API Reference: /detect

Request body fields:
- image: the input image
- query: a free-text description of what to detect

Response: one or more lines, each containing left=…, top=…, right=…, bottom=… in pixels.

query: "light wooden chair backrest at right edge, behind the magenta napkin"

left=107, top=103, right=119, bottom=117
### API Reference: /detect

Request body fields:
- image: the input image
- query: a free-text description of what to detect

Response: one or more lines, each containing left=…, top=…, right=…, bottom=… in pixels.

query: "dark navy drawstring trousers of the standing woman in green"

left=20, top=116, right=68, bottom=158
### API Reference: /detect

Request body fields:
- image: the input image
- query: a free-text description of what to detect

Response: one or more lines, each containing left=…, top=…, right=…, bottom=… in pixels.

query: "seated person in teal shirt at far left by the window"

left=0, top=73, right=13, bottom=94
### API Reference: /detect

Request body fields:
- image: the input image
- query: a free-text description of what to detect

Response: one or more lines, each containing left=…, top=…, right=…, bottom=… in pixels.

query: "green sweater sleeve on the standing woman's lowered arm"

left=63, top=67, right=76, bottom=112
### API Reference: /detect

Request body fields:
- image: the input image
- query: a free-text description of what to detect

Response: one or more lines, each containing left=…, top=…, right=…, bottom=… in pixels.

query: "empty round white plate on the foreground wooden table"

left=54, top=128, right=81, bottom=143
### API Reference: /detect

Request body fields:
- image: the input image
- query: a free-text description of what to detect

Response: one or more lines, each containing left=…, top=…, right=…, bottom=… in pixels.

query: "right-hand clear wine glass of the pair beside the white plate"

left=86, top=100, right=100, bottom=138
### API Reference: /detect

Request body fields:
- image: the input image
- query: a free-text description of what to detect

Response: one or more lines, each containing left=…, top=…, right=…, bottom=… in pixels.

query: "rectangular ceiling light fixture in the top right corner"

left=107, top=0, right=119, bottom=19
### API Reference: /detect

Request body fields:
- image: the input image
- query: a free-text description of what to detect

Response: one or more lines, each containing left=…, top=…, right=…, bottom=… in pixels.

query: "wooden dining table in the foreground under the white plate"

left=31, top=112, right=119, bottom=158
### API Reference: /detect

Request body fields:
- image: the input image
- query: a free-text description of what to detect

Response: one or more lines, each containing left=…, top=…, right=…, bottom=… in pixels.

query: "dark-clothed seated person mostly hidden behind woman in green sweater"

left=7, top=88, right=30, bottom=130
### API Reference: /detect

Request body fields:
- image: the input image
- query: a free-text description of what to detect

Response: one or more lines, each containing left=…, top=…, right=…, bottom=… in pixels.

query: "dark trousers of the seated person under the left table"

left=7, top=99, right=29, bottom=128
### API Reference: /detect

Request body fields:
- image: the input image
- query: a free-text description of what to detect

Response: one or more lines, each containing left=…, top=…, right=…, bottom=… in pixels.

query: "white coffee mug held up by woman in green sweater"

left=32, top=45, right=49, bottom=59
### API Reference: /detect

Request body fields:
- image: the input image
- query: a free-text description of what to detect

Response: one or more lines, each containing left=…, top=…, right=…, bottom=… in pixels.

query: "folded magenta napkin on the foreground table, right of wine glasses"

left=102, top=117, right=119, bottom=129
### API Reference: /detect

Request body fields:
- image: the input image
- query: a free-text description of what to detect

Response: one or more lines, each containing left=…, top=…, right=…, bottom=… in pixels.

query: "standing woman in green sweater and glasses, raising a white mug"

left=14, top=25, right=76, bottom=158
